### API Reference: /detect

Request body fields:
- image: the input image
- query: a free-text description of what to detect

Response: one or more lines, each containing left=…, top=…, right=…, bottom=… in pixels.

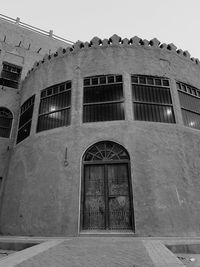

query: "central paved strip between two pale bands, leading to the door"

left=16, top=237, right=155, bottom=267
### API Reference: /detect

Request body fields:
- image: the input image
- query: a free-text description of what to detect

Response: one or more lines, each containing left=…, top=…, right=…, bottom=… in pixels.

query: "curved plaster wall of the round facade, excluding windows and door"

left=1, top=35, right=200, bottom=236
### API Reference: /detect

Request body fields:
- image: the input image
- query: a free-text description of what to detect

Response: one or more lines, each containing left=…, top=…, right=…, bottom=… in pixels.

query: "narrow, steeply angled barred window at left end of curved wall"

left=17, top=95, right=35, bottom=143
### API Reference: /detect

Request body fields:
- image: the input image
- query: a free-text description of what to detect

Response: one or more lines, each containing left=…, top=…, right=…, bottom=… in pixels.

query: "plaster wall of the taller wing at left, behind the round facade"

left=0, top=19, right=70, bottom=199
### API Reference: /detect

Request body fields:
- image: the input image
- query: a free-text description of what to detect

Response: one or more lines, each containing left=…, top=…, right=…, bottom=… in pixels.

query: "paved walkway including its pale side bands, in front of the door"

left=0, top=236, right=200, bottom=267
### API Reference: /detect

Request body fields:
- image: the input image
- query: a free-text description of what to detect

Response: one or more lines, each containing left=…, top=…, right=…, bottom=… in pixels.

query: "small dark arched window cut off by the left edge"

left=0, top=108, right=13, bottom=138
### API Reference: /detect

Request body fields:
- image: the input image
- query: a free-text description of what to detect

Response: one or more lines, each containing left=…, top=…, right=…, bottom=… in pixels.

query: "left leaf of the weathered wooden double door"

left=83, top=165, right=105, bottom=229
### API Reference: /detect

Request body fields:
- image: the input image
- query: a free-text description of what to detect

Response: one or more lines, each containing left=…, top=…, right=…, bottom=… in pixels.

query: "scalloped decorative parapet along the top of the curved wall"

left=24, top=34, right=200, bottom=79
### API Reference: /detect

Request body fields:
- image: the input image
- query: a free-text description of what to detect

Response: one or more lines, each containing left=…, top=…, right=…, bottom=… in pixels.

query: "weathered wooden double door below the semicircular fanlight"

left=82, top=163, right=134, bottom=231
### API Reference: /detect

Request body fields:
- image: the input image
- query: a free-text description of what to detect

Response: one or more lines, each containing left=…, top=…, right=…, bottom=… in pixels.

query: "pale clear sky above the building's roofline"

left=0, top=0, right=200, bottom=59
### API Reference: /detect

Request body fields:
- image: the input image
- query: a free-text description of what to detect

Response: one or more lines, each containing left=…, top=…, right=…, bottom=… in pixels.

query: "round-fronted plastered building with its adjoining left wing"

left=0, top=14, right=200, bottom=236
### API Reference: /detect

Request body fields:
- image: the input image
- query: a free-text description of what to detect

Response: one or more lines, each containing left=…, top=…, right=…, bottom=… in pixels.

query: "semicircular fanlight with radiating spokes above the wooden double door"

left=83, top=141, right=130, bottom=162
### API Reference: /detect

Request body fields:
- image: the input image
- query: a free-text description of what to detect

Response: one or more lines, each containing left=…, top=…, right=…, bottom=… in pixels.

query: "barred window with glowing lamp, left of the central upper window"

left=37, top=81, right=71, bottom=132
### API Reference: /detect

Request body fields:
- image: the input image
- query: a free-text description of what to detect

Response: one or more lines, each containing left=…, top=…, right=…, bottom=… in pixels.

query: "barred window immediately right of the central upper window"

left=131, top=75, right=175, bottom=123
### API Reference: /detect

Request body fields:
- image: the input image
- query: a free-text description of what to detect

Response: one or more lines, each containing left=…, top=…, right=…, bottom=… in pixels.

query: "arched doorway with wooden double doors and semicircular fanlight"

left=81, top=141, right=134, bottom=231
